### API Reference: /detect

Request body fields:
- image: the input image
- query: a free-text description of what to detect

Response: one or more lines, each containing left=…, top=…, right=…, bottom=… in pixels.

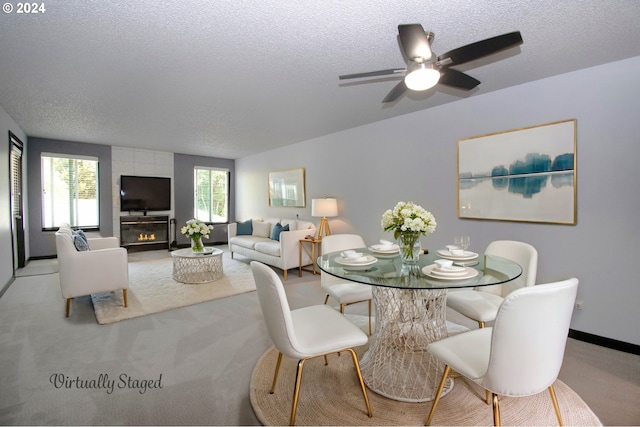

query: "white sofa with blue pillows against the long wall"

left=227, top=218, right=316, bottom=280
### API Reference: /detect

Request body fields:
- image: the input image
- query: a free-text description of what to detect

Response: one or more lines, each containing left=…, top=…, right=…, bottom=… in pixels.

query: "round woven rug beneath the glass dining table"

left=249, top=347, right=602, bottom=426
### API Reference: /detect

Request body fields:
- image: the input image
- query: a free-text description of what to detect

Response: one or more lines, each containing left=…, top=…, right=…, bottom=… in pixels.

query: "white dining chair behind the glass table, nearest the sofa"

left=320, top=234, right=373, bottom=335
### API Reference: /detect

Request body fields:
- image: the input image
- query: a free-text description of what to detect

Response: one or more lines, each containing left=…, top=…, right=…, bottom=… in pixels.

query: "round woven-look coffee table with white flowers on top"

left=171, top=248, right=224, bottom=284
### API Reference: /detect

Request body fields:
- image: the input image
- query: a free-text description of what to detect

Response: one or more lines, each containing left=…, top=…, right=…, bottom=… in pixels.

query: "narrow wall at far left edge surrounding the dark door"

left=0, top=106, right=29, bottom=290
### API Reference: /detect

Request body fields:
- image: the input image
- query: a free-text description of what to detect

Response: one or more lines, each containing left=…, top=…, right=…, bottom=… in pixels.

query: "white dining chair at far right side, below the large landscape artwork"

left=447, top=240, right=538, bottom=328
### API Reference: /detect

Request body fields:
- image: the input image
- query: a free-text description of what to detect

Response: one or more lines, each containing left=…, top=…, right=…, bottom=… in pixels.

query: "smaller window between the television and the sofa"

left=194, top=167, right=229, bottom=222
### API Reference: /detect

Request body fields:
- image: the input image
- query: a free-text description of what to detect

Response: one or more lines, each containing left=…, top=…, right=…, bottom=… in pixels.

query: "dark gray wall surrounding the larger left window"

left=26, top=138, right=113, bottom=258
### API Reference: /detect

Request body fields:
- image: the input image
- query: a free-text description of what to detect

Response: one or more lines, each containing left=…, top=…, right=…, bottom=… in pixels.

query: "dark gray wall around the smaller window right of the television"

left=173, top=154, right=236, bottom=245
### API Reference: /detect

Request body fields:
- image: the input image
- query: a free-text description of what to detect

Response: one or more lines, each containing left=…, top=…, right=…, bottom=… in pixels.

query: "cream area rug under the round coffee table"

left=91, top=252, right=256, bottom=325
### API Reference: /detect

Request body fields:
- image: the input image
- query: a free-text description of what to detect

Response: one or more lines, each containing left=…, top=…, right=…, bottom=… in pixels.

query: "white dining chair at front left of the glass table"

left=251, top=261, right=372, bottom=425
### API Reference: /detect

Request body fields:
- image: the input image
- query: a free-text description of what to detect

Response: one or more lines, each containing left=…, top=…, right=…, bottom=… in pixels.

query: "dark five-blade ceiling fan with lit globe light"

left=339, top=24, right=522, bottom=103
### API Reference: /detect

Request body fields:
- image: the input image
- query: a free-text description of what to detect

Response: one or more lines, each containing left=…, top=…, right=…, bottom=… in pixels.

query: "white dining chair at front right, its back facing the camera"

left=426, top=278, right=578, bottom=426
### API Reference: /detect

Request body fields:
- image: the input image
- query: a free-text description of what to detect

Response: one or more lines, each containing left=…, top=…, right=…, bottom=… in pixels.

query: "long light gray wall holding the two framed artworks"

left=236, top=57, right=640, bottom=345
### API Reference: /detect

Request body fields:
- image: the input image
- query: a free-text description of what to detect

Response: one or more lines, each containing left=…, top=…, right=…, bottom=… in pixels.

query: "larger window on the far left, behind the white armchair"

left=41, top=153, right=100, bottom=230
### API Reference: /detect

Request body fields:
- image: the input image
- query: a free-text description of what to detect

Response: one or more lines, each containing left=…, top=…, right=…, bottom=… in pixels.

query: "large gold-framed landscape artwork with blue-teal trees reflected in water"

left=458, top=119, right=577, bottom=225
